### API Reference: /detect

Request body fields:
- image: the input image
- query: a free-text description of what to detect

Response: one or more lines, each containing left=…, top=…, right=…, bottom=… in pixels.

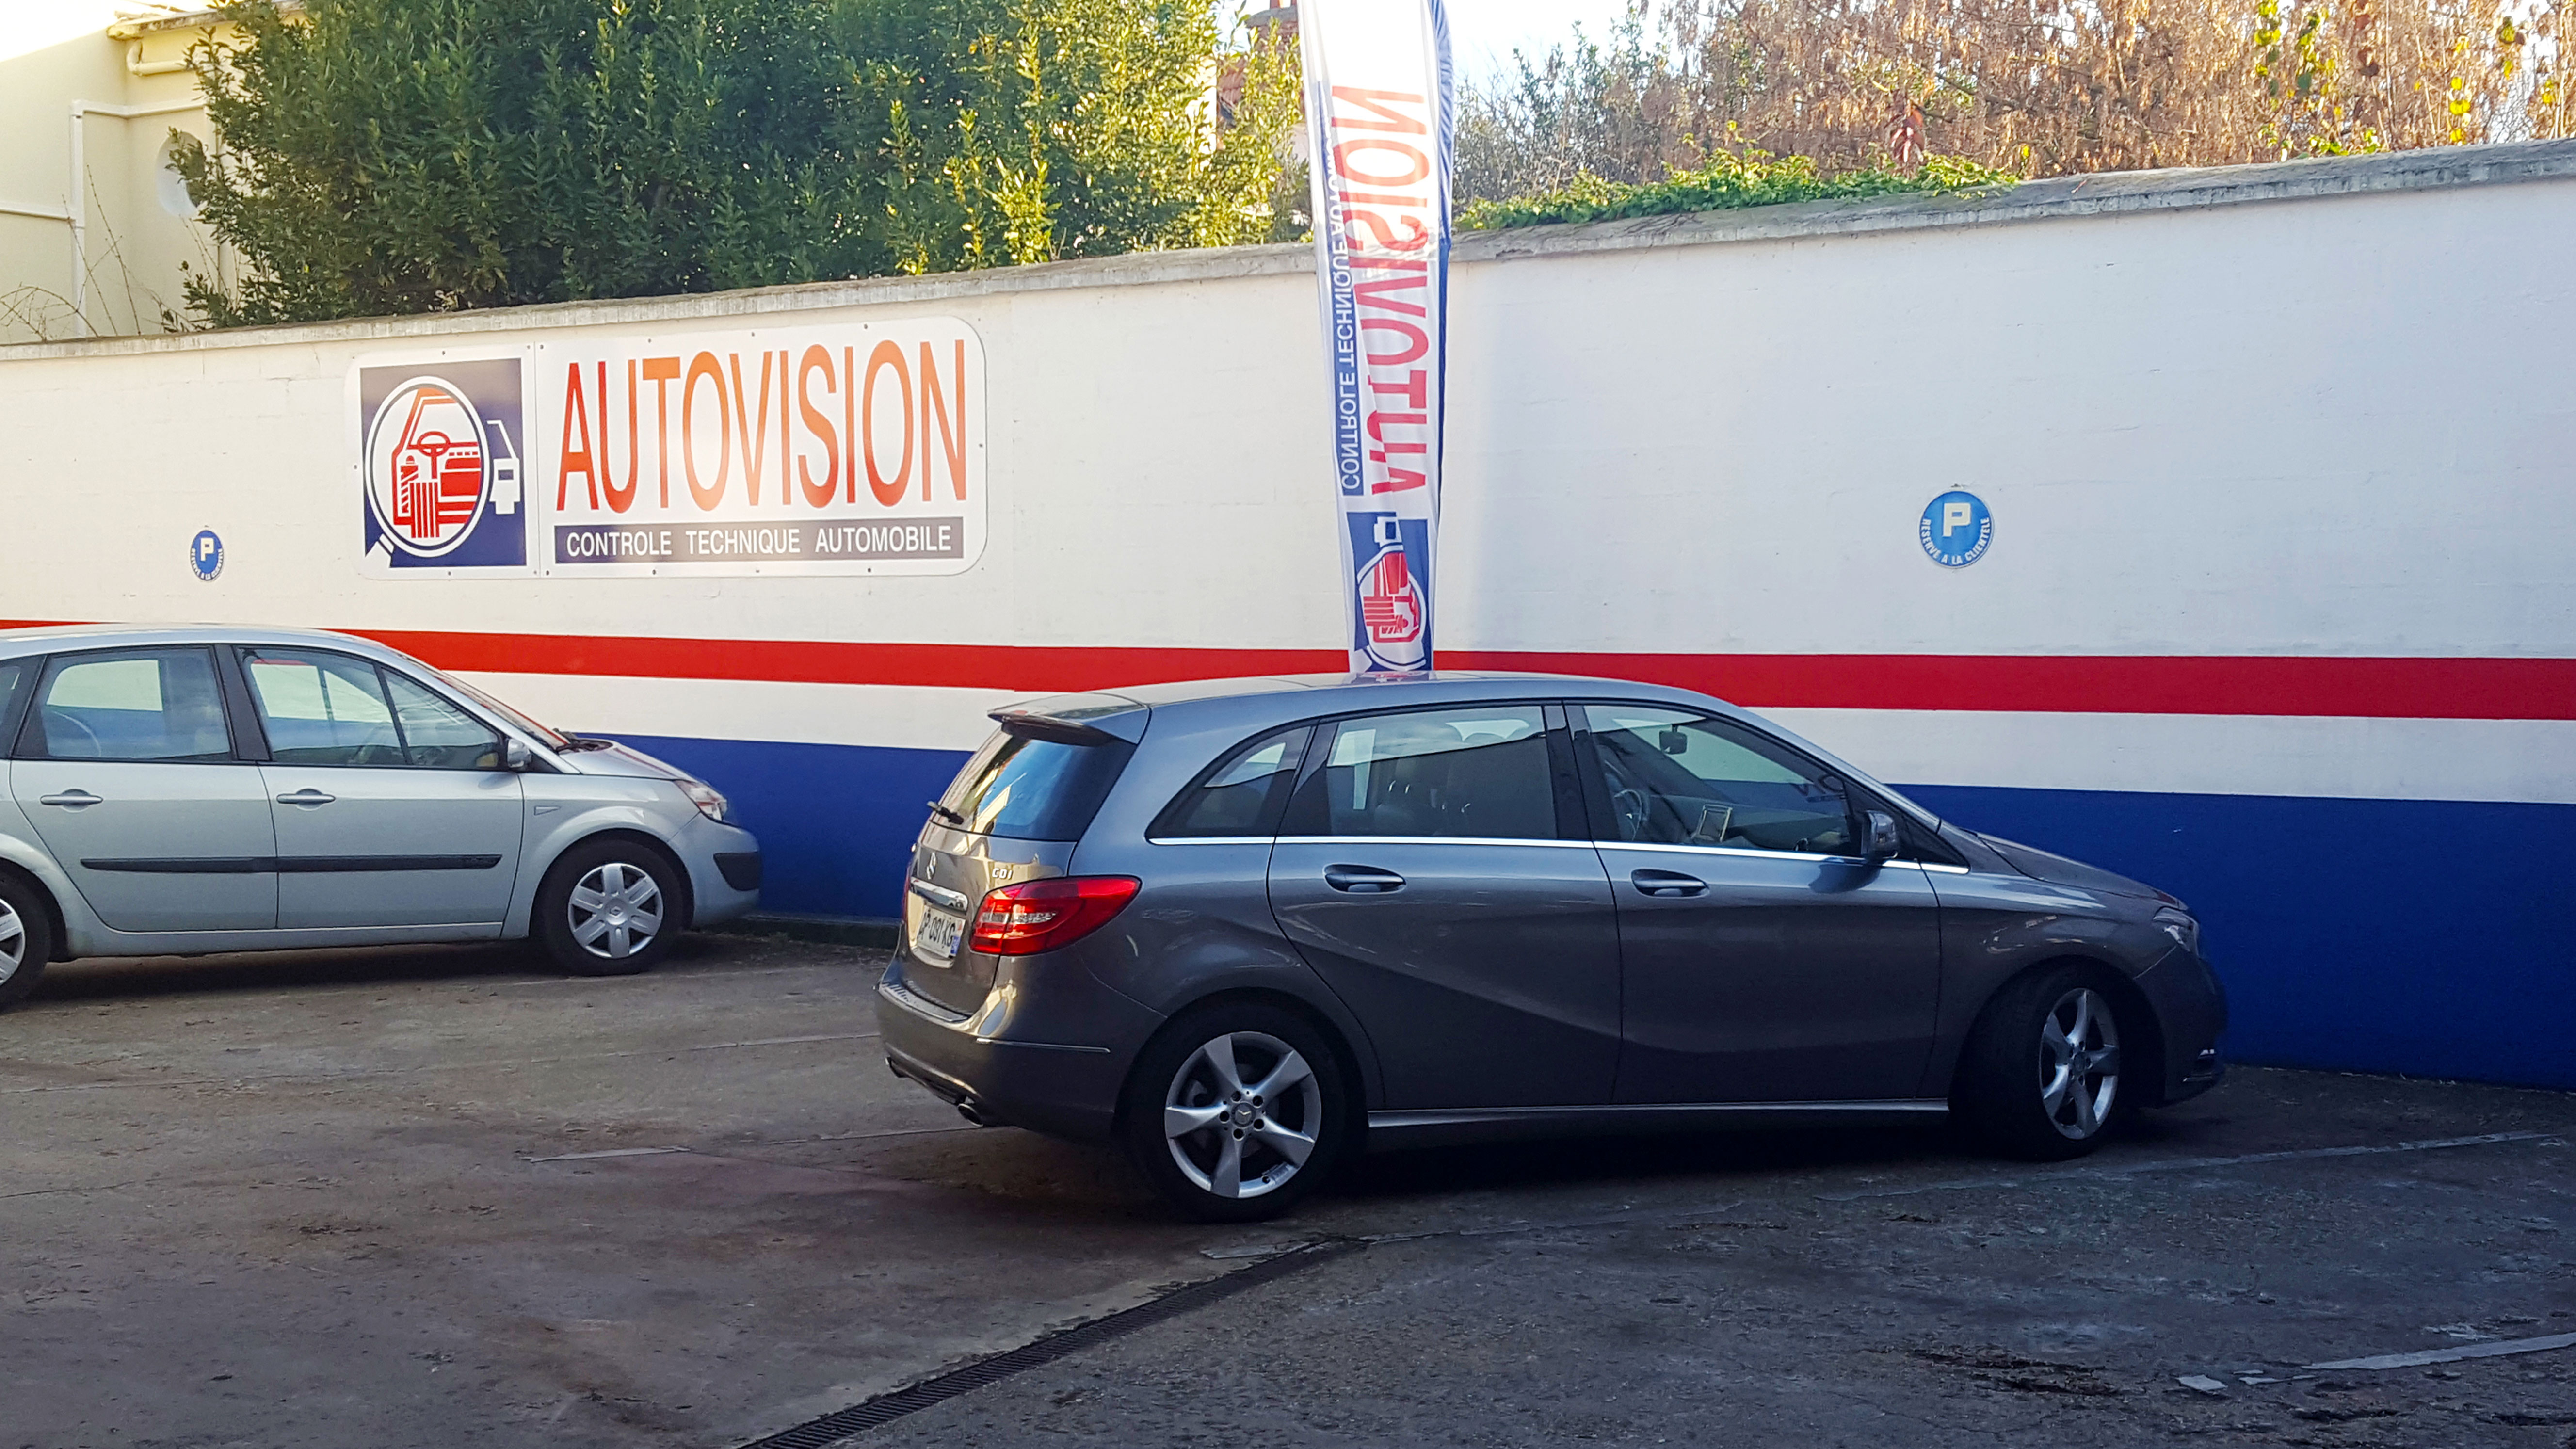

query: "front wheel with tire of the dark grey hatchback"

left=1950, top=964, right=2146, bottom=1163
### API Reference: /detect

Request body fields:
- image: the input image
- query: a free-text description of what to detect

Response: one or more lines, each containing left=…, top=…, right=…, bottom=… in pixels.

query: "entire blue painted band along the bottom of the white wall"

left=618, top=735, right=2576, bottom=1088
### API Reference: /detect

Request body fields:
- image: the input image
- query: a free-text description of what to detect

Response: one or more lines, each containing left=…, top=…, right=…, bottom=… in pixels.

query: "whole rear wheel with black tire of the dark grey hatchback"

left=1118, top=1000, right=1360, bottom=1222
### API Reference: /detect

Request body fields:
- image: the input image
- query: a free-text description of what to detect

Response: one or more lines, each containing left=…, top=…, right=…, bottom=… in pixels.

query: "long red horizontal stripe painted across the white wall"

left=0, top=613, right=2576, bottom=719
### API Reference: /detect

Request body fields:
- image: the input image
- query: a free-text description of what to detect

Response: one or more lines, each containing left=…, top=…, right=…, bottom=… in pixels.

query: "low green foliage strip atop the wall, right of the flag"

left=1458, top=152, right=2022, bottom=232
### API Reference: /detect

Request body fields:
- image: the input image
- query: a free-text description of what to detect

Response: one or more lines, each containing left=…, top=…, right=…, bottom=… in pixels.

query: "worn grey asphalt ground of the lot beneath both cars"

left=0, top=936, right=2576, bottom=1449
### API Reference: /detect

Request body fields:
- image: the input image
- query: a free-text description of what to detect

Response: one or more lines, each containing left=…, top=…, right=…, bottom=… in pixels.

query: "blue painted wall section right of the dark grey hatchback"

left=1904, top=787, right=2576, bottom=1088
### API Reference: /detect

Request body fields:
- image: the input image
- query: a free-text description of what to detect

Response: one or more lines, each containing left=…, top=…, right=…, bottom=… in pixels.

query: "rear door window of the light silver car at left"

left=28, top=650, right=232, bottom=763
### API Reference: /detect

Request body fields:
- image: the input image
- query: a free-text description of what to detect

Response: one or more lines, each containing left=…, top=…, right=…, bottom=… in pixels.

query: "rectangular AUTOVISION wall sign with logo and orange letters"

left=350, top=317, right=986, bottom=578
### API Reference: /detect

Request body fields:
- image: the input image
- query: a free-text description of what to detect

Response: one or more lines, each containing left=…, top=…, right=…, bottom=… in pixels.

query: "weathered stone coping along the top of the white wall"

left=20, top=139, right=2576, bottom=364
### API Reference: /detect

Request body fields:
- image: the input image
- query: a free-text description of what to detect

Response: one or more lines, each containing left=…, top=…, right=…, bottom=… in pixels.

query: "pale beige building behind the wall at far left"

left=0, top=0, right=274, bottom=343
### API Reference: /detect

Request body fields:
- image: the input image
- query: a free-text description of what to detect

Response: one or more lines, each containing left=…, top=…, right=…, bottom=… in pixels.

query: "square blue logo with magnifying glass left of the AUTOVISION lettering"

left=358, top=358, right=528, bottom=570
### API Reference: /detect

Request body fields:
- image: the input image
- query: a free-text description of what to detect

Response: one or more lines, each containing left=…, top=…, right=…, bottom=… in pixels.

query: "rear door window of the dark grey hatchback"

left=1319, top=704, right=1556, bottom=840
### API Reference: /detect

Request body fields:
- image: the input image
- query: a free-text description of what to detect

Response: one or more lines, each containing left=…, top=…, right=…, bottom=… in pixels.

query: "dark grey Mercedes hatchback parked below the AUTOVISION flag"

left=876, top=673, right=2226, bottom=1220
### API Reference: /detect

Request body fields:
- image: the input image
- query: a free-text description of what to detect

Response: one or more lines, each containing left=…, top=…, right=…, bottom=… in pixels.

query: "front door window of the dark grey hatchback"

left=1584, top=704, right=1852, bottom=856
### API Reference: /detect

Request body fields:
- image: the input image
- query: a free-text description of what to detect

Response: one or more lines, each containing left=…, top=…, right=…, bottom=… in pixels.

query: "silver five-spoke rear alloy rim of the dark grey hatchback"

left=1162, top=1031, right=1324, bottom=1196
